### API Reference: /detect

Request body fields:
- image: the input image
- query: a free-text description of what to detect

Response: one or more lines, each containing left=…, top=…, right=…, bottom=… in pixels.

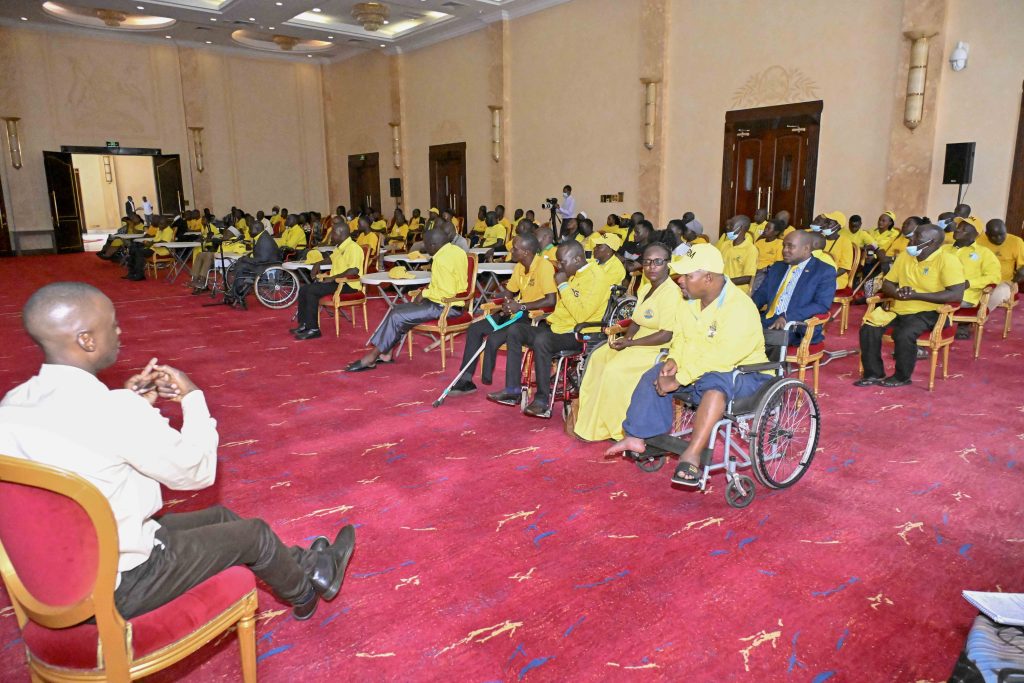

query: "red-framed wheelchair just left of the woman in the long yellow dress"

left=519, top=285, right=637, bottom=423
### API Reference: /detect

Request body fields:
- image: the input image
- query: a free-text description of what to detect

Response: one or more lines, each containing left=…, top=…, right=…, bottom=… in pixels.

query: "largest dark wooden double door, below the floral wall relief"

left=721, top=102, right=821, bottom=226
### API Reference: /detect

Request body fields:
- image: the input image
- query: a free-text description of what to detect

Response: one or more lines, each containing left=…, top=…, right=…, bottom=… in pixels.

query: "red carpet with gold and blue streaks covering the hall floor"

left=0, top=255, right=1024, bottom=682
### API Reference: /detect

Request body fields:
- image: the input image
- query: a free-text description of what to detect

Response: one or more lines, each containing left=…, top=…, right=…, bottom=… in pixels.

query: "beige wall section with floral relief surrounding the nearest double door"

left=664, top=0, right=906, bottom=234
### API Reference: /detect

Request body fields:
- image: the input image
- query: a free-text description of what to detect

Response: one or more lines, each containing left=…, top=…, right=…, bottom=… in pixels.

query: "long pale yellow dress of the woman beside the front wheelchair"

left=575, top=278, right=683, bottom=441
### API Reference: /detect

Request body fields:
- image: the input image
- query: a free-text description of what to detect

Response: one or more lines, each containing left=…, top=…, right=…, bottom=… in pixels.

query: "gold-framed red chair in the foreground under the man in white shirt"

left=0, top=456, right=257, bottom=683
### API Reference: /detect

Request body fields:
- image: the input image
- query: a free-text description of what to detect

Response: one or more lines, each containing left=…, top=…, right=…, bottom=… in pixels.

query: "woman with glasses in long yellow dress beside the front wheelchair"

left=575, top=243, right=683, bottom=441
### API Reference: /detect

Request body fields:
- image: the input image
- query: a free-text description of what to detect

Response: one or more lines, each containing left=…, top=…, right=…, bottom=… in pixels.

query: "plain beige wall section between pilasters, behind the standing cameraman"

left=505, top=0, right=644, bottom=224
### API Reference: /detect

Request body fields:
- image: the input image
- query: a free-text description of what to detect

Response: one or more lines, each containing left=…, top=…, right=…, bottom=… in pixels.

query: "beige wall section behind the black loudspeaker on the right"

left=925, top=0, right=1024, bottom=220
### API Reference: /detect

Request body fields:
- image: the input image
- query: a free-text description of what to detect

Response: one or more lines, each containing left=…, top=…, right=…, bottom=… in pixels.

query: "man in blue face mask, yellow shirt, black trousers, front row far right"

left=853, top=223, right=966, bottom=387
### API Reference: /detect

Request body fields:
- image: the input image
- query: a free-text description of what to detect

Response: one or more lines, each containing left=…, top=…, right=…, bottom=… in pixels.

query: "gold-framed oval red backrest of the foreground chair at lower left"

left=0, top=456, right=124, bottom=634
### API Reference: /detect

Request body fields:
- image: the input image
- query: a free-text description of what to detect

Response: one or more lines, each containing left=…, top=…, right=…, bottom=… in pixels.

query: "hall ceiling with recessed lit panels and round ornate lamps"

left=0, top=0, right=568, bottom=60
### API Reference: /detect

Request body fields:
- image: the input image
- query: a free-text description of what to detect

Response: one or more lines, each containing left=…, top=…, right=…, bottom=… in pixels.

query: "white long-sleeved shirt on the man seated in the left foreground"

left=0, top=365, right=219, bottom=584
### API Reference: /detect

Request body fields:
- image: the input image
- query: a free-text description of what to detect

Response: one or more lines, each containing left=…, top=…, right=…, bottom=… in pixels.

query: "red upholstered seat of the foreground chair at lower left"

left=22, top=567, right=256, bottom=670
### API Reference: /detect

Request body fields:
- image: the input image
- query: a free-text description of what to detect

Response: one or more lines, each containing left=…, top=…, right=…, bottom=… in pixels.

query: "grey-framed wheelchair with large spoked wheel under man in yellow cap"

left=623, top=321, right=821, bottom=508
